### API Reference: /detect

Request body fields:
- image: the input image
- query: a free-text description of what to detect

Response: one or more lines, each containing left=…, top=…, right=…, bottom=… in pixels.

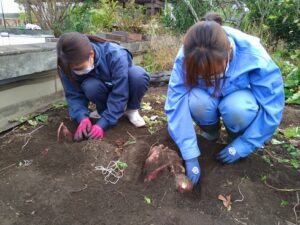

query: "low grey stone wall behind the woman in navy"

left=0, top=41, right=149, bottom=132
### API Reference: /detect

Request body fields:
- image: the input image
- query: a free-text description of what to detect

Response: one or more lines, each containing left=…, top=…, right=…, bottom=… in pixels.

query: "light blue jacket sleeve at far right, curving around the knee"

left=231, top=57, right=284, bottom=157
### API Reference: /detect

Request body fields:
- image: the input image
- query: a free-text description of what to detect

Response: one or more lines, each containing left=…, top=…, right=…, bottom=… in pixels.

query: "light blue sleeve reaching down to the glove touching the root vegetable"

left=165, top=49, right=200, bottom=160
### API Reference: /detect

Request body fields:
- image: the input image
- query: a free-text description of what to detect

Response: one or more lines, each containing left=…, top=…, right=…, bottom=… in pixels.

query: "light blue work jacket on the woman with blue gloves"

left=165, top=26, right=284, bottom=160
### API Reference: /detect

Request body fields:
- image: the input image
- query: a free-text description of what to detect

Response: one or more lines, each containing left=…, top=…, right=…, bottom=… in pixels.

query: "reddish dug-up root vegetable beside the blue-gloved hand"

left=144, top=144, right=193, bottom=193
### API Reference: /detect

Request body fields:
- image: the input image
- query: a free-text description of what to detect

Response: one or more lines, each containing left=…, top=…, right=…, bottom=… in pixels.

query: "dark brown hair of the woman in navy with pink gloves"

left=56, top=32, right=108, bottom=82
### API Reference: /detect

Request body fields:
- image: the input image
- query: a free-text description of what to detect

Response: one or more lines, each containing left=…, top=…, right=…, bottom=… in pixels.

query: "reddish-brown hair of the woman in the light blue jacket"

left=183, top=15, right=230, bottom=93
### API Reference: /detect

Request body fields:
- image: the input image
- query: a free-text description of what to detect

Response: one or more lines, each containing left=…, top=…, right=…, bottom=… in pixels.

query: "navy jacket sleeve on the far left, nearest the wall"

left=60, top=71, right=89, bottom=123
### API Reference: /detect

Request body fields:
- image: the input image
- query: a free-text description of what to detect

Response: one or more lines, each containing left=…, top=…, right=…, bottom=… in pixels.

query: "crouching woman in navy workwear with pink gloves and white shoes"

left=57, top=32, right=150, bottom=141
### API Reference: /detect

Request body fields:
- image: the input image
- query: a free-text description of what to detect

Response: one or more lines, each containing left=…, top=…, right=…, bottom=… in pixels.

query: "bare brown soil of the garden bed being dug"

left=0, top=87, right=300, bottom=225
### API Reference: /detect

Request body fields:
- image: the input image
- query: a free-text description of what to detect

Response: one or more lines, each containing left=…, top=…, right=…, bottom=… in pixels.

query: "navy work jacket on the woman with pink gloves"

left=60, top=42, right=132, bottom=130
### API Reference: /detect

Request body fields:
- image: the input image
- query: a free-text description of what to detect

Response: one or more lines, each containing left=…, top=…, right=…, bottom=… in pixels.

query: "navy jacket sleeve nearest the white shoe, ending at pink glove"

left=97, top=52, right=129, bottom=130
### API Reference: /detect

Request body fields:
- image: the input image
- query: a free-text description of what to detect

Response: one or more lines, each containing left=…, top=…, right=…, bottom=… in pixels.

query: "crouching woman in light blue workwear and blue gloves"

left=165, top=13, right=284, bottom=187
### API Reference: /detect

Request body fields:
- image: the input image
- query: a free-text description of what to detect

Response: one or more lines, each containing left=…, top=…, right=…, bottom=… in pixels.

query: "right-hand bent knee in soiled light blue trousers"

left=219, top=91, right=258, bottom=133
